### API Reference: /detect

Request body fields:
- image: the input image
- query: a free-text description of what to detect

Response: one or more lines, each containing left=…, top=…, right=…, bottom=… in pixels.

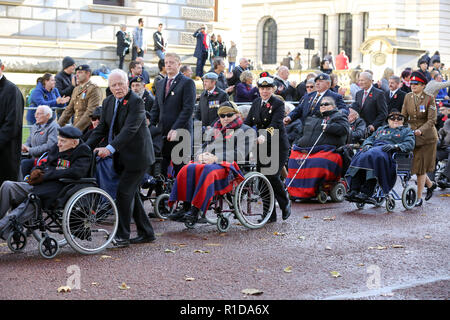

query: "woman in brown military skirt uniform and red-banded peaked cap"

left=402, top=71, right=438, bottom=206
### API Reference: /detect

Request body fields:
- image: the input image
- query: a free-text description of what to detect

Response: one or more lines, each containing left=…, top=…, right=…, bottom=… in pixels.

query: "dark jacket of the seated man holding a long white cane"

left=295, top=109, right=350, bottom=148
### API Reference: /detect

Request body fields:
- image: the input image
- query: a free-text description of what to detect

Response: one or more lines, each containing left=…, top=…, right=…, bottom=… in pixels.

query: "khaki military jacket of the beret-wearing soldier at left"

left=58, top=81, right=103, bottom=131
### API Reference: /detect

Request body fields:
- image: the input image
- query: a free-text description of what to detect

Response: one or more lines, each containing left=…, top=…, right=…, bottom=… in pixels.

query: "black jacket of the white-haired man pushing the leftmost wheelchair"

left=87, top=90, right=155, bottom=173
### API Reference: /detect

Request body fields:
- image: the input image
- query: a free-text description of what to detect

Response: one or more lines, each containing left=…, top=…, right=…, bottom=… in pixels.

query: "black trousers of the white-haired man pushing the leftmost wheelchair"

left=116, top=169, right=154, bottom=239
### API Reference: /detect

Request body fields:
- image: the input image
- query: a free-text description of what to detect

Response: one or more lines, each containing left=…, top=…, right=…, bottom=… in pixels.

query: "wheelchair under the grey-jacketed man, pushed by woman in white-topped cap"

left=154, top=162, right=275, bottom=232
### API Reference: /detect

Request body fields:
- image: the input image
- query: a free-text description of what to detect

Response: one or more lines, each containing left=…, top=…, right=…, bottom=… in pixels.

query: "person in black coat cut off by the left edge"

left=0, top=59, right=24, bottom=185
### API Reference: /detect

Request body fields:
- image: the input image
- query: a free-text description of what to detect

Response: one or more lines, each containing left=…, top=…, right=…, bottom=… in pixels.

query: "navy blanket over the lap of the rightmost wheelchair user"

left=346, top=141, right=397, bottom=194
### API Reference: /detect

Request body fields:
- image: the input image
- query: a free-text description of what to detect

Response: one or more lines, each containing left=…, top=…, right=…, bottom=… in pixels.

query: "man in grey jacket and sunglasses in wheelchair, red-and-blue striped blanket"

left=168, top=101, right=274, bottom=231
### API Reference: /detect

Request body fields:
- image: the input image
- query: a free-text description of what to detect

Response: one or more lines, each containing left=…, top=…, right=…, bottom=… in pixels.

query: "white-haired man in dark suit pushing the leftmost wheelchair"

left=86, top=69, right=155, bottom=247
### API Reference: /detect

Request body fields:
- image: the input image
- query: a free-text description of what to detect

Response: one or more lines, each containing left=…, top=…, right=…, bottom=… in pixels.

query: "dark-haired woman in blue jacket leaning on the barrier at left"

left=27, top=73, right=70, bottom=124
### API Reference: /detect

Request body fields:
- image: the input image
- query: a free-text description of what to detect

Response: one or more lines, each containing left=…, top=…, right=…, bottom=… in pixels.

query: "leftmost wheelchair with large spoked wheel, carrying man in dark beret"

left=2, top=152, right=119, bottom=259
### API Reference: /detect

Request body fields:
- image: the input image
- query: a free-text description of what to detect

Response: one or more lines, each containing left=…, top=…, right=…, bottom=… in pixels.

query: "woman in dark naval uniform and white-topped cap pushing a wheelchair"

left=244, top=72, right=291, bottom=222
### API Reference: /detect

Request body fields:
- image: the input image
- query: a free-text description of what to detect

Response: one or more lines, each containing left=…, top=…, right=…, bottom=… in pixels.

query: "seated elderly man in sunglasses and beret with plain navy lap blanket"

left=345, top=110, right=415, bottom=205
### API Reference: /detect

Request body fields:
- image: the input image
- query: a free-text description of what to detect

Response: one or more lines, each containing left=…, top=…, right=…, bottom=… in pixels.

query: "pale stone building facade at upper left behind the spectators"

left=0, top=0, right=243, bottom=72
